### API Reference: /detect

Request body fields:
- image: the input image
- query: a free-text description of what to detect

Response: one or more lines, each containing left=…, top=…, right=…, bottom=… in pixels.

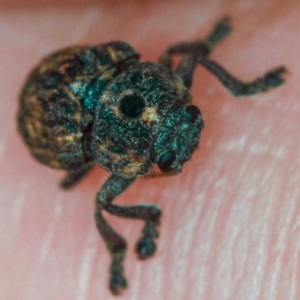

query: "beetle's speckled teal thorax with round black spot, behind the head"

left=92, top=62, right=189, bottom=177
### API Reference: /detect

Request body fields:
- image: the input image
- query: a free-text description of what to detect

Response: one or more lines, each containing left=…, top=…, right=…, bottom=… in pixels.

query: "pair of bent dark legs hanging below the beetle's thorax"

left=95, top=175, right=160, bottom=294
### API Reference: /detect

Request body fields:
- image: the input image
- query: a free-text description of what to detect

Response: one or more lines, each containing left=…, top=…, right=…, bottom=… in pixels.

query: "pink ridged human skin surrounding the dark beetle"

left=0, top=0, right=300, bottom=300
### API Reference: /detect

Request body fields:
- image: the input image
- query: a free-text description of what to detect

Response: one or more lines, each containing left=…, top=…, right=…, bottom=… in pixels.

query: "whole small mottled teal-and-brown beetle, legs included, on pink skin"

left=18, top=18, right=286, bottom=294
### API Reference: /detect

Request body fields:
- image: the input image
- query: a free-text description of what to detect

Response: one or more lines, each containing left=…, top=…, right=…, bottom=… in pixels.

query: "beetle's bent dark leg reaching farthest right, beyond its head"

left=196, top=56, right=286, bottom=97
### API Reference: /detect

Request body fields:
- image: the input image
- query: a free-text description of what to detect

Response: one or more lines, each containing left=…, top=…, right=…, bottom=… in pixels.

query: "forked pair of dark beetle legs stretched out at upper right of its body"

left=160, top=18, right=286, bottom=97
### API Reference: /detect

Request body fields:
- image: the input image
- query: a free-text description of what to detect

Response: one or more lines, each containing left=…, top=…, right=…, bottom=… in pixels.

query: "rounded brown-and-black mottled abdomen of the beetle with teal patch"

left=18, top=42, right=138, bottom=170
